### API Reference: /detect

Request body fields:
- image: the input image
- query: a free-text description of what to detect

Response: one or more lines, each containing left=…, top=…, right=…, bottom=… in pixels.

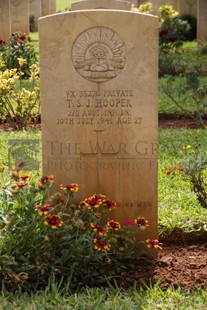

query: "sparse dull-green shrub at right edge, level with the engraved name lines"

left=162, top=66, right=207, bottom=124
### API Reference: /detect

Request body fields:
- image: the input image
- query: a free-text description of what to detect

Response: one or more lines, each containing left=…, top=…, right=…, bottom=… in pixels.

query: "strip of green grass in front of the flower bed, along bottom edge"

left=0, top=285, right=207, bottom=310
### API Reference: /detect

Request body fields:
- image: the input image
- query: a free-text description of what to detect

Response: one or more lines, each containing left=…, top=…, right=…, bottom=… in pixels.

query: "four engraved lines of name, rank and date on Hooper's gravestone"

left=56, top=89, right=143, bottom=126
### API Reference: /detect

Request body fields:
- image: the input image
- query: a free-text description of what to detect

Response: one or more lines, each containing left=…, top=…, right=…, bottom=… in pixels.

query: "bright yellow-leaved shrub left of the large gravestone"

left=0, top=58, right=40, bottom=129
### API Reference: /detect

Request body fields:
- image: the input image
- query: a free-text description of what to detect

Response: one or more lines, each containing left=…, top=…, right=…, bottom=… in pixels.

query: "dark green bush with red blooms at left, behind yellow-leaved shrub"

left=0, top=32, right=37, bottom=78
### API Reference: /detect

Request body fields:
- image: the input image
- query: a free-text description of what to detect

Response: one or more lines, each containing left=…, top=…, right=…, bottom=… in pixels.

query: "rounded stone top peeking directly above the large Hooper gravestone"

left=71, top=0, right=132, bottom=11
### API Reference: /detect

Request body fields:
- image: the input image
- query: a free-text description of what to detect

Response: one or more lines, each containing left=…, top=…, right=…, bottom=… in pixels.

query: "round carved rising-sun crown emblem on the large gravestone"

left=72, top=27, right=126, bottom=83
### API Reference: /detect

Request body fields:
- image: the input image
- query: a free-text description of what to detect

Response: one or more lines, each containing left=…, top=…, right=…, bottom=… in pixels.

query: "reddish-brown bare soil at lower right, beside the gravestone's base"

left=116, top=243, right=207, bottom=291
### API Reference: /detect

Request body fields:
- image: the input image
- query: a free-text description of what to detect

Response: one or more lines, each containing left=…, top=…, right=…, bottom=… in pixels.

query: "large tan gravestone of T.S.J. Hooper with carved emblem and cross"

left=39, top=10, right=158, bottom=252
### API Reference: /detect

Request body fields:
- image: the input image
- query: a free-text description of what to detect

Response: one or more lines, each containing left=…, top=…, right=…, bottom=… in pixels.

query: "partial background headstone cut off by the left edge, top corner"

left=0, top=0, right=11, bottom=41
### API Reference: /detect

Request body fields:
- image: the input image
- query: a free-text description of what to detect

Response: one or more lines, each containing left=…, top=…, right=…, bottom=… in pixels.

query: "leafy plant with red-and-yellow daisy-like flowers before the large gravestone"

left=0, top=166, right=154, bottom=290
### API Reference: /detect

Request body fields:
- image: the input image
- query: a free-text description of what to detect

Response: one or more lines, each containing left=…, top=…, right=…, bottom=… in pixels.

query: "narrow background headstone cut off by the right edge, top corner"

left=197, top=0, right=207, bottom=41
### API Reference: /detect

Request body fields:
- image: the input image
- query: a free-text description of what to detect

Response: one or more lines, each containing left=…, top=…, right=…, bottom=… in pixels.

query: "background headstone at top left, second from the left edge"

left=10, top=0, right=29, bottom=34
